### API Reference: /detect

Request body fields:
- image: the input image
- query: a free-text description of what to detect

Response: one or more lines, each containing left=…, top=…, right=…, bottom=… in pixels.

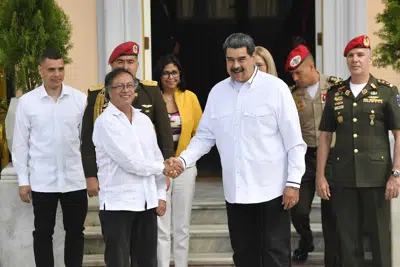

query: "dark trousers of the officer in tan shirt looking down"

left=291, top=147, right=340, bottom=267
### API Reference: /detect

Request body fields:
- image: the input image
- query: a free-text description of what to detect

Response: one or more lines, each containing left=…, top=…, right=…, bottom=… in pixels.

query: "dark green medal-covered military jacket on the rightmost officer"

left=319, top=75, right=400, bottom=187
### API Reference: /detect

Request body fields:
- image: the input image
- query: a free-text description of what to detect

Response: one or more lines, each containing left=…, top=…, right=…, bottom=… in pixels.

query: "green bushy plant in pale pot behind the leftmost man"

left=0, top=0, right=72, bottom=155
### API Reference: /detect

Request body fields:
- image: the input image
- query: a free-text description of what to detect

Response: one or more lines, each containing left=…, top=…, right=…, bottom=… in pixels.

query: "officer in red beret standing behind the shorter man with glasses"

left=81, top=42, right=174, bottom=200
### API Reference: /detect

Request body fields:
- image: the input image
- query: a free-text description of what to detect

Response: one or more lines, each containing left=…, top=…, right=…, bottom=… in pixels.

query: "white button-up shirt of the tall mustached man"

left=180, top=68, right=307, bottom=203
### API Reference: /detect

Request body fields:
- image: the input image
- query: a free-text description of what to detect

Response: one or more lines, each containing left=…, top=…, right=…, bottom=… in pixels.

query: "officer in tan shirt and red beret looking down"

left=286, top=45, right=341, bottom=267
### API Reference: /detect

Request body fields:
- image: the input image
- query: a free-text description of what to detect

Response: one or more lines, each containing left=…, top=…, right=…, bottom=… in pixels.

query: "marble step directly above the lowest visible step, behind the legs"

left=85, top=223, right=350, bottom=254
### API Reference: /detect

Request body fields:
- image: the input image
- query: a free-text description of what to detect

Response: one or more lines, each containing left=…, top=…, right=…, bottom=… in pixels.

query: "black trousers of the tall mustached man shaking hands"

left=226, top=197, right=291, bottom=267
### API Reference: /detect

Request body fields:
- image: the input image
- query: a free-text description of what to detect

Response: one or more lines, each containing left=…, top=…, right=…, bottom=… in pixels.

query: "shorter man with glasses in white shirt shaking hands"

left=93, top=68, right=176, bottom=267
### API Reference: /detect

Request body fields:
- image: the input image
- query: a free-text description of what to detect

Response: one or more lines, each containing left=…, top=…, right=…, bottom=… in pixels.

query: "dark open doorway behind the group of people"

left=151, top=0, right=315, bottom=176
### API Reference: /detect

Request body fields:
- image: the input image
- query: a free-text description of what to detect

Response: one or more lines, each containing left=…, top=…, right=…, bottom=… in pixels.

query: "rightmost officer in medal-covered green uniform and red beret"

left=317, top=36, right=400, bottom=267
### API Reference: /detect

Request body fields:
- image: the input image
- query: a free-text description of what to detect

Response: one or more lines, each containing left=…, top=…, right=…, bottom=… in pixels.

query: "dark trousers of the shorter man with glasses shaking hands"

left=99, top=209, right=157, bottom=267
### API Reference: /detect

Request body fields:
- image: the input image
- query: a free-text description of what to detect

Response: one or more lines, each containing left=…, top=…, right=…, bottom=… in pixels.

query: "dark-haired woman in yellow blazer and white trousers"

left=153, top=55, right=202, bottom=267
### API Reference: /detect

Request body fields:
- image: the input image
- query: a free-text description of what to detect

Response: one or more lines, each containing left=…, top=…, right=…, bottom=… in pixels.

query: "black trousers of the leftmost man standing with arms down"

left=32, top=189, right=88, bottom=267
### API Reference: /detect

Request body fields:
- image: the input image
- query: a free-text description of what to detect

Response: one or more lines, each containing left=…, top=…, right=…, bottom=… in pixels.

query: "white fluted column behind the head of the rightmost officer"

left=322, top=0, right=367, bottom=78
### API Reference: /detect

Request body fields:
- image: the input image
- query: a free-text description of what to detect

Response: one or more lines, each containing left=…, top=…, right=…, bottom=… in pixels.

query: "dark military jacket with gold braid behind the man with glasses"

left=81, top=80, right=174, bottom=177
